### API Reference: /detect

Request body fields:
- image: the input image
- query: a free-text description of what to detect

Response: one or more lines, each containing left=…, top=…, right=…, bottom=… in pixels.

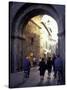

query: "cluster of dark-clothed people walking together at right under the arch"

left=39, top=55, right=64, bottom=82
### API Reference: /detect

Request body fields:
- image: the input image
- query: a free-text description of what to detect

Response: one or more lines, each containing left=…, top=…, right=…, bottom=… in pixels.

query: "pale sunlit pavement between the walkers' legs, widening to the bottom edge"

left=18, top=67, right=60, bottom=87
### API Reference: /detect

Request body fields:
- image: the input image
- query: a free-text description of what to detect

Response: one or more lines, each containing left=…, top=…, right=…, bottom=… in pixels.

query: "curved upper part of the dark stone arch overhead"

left=12, top=4, right=60, bottom=32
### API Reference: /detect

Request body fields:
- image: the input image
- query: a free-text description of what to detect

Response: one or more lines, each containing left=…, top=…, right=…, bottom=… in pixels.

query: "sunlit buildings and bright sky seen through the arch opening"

left=22, top=14, right=58, bottom=65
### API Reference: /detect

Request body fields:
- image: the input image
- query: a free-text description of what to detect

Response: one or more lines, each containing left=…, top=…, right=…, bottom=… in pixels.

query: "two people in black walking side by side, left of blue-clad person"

left=39, top=57, right=52, bottom=80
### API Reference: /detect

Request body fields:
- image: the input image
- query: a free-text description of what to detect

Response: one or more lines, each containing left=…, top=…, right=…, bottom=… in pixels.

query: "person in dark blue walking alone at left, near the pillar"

left=23, top=56, right=31, bottom=78
